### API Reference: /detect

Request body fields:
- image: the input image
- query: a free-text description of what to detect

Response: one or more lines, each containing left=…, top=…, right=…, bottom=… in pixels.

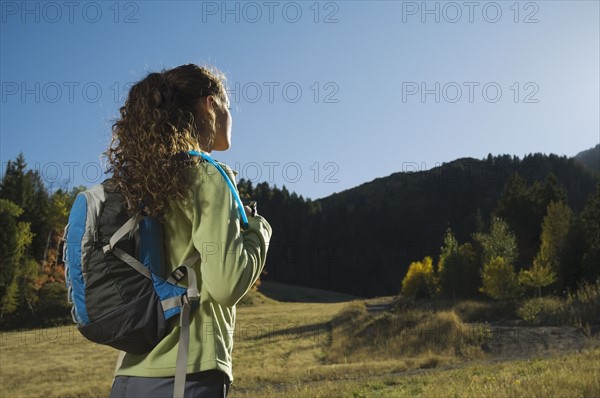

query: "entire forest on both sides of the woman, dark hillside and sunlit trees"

left=0, top=150, right=600, bottom=329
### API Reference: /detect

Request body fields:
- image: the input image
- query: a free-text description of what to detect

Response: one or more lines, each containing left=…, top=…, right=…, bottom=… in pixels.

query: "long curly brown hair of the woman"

left=105, top=64, right=226, bottom=217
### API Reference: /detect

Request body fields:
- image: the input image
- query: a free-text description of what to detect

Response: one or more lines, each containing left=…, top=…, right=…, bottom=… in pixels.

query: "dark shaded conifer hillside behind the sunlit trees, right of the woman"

left=240, top=154, right=600, bottom=297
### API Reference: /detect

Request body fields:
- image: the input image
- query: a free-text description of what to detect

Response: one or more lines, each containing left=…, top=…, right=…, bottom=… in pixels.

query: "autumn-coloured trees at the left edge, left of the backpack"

left=0, top=154, right=83, bottom=329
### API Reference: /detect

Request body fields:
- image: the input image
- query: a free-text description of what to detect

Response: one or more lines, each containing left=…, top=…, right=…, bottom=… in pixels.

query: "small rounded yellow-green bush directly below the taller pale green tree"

left=480, top=256, right=521, bottom=300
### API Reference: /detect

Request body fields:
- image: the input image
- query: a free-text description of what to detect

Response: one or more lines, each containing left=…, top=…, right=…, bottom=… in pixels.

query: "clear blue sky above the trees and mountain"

left=0, top=1, right=600, bottom=199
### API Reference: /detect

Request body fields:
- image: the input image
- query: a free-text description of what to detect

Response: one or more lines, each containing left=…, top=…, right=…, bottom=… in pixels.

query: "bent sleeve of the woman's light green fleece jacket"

left=192, top=164, right=272, bottom=307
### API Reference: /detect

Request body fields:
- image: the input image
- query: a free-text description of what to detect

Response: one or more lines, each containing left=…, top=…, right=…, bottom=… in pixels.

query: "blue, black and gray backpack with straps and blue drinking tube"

left=62, top=151, right=248, bottom=396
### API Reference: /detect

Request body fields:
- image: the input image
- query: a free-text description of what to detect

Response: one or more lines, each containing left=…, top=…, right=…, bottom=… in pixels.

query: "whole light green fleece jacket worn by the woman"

left=115, top=162, right=271, bottom=381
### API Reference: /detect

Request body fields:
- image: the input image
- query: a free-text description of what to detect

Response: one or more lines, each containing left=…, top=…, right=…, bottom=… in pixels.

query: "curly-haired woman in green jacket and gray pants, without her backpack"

left=107, top=64, right=271, bottom=397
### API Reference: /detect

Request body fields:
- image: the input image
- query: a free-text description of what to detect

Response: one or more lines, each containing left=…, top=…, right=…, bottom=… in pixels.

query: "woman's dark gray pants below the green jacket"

left=110, top=369, right=231, bottom=398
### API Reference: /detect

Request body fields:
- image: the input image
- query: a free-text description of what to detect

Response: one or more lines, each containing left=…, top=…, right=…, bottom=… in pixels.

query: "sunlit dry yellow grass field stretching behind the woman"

left=0, top=286, right=600, bottom=398
